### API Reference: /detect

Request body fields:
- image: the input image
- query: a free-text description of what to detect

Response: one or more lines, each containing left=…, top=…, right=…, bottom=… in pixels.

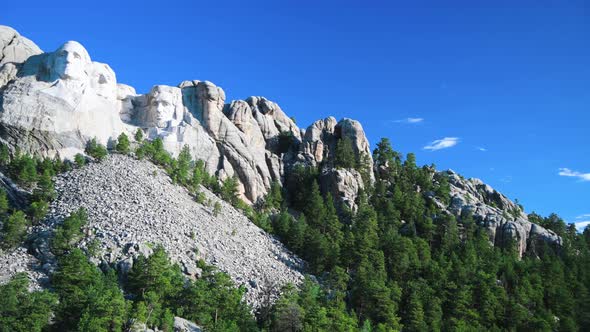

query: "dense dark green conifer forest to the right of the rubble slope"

left=267, top=139, right=590, bottom=331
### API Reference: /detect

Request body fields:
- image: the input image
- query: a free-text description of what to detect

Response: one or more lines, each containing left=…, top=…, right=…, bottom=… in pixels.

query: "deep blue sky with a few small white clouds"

left=0, top=1, right=590, bottom=228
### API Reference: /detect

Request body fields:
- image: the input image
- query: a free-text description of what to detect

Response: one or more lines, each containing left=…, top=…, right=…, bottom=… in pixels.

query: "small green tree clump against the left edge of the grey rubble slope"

left=51, top=208, right=88, bottom=255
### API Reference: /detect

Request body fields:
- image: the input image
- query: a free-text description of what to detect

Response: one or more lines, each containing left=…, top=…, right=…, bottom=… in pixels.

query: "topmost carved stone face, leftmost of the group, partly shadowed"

left=51, top=41, right=90, bottom=80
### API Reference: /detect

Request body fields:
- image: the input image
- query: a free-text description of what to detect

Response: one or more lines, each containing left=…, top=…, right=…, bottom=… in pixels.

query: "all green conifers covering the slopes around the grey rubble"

left=0, top=136, right=590, bottom=331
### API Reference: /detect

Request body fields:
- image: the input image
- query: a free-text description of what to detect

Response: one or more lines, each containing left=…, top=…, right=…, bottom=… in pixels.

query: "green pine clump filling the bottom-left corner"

left=0, top=273, right=57, bottom=332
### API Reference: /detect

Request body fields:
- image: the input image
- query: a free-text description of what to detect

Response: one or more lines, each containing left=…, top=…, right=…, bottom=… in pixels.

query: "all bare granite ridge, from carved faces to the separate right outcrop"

left=0, top=27, right=561, bottom=256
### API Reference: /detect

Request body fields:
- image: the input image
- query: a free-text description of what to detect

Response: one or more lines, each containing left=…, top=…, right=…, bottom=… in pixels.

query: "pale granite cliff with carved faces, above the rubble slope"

left=0, top=27, right=370, bottom=205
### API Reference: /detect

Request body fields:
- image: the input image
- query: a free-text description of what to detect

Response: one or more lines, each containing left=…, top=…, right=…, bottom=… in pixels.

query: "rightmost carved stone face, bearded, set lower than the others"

left=147, top=85, right=182, bottom=128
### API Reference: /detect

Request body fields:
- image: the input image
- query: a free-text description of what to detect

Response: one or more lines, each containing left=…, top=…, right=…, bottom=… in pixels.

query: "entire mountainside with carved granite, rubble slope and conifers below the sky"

left=0, top=26, right=590, bottom=331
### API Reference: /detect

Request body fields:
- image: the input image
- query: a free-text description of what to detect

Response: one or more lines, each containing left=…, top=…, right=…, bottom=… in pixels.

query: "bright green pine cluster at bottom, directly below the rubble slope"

left=127, top=246, right=256, bottom=331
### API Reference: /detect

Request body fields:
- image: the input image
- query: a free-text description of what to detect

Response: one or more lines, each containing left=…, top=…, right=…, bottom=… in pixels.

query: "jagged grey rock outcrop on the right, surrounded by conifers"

left=437, top=170, right=562, bottom=257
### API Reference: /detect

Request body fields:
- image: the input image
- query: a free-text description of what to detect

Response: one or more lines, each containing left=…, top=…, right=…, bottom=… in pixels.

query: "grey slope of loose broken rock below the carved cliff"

left=47, top=155, right=303, bottom=308
